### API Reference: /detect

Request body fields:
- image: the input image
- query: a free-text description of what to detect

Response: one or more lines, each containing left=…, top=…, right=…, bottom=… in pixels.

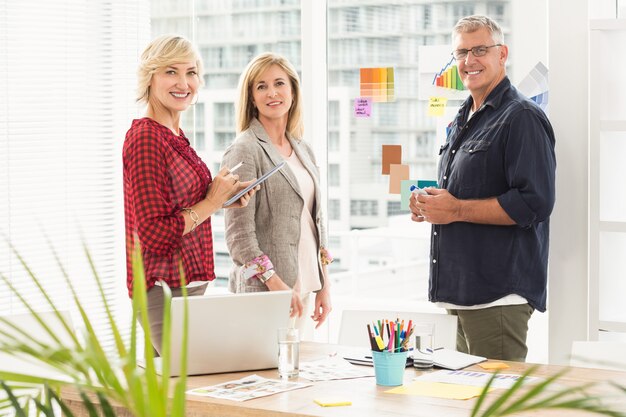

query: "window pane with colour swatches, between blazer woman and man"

left=327, top=0, right=511, bottom=309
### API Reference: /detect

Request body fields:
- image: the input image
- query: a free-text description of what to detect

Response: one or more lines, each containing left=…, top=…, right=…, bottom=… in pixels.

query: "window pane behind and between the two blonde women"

left=150, top=0, right=302, bottom=287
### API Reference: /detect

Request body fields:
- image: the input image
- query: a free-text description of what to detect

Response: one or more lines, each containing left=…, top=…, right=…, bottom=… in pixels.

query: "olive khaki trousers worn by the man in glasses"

left=448, top=304, right=534, bottom=362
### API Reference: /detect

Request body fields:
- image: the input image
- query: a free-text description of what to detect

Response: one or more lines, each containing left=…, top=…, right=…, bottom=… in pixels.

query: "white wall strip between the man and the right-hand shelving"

left=548, top=0, right=595, bottom=364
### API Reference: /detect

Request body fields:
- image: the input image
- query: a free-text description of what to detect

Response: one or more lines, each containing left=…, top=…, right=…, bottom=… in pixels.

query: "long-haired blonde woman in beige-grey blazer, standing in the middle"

left=222, top=53, right=332, bottom=331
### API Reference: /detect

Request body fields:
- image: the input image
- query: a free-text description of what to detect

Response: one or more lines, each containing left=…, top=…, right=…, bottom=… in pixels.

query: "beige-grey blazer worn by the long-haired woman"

left=222, top=119, right=326, bottom=292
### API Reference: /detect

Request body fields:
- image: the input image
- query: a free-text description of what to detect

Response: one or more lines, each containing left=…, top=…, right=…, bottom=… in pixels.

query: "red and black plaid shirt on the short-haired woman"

left=122, top=118, right=215, bottom=297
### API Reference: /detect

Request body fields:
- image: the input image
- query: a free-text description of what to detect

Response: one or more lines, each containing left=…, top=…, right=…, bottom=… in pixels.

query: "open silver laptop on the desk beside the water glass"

left=150, top=291, right=291, bottom=376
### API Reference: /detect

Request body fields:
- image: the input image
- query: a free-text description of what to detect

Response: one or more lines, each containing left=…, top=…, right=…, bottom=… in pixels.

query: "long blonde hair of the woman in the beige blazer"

left=235, top=52, right=304, bottom=139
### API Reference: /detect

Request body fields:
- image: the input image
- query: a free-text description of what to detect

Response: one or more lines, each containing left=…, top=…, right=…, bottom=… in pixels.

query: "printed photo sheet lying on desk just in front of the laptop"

left=187, top=375, right=311, bottom=401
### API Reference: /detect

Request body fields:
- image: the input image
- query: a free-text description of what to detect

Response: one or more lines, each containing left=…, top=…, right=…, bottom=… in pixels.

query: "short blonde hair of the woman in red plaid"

left=137, top=35, right=204, bottom=103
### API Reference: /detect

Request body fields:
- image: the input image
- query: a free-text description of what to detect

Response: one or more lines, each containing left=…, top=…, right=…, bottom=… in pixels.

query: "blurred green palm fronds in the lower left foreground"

left=0, top=240, right=188, bottom=417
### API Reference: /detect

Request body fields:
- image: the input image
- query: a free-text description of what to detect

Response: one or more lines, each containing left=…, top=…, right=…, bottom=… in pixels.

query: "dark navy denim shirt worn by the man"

left=429, top=78, right=556, bottom=311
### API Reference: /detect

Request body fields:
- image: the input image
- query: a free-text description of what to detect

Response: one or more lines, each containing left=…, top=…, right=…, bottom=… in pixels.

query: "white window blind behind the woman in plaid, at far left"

left=0, top=0, right=149, bottom=352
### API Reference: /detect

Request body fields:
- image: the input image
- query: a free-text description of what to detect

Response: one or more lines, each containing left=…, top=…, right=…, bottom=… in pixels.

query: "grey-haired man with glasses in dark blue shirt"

left=410, top=16, right=556, bottom=361
